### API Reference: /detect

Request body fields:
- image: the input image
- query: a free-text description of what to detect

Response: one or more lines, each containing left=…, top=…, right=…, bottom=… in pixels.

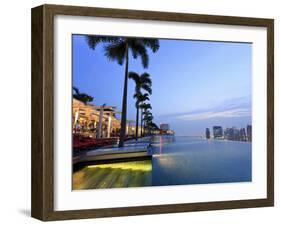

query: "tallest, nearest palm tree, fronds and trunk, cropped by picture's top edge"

left=87, top=35, right=159, bottom=147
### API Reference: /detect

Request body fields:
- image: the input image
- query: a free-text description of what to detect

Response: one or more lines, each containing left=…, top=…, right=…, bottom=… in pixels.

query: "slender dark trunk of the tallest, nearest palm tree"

left=119, top=43, right=129, bottom=147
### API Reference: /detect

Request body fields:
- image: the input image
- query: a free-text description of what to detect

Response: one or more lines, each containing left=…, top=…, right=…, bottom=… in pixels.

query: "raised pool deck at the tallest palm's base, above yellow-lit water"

left=73, top=138, right=152, bottom=170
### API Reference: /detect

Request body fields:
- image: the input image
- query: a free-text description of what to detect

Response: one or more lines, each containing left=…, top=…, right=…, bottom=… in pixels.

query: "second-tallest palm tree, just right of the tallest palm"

left=129, top=72, right=152, bottom=140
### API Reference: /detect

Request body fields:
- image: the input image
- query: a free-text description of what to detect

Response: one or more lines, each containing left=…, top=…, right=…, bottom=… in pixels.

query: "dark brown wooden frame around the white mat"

left=31, top=5, right=274, bottom=221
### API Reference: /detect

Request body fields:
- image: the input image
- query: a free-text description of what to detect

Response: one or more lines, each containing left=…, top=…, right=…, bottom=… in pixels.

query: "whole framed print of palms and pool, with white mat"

left=32, top=5, right=274, bottom=221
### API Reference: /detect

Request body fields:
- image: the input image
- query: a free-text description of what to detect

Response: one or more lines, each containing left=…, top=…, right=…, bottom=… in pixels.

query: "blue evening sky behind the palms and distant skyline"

left=73, top=35, right=252, bottom=135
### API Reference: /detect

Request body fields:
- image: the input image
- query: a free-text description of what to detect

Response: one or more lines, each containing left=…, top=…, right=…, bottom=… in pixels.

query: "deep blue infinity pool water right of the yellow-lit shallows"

left=151, top=137, right=252, bottom=186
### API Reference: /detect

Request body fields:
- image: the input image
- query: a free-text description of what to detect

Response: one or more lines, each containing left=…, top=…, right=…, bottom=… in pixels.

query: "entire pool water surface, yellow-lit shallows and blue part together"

left=73, top=136, right=252, bottom=189
